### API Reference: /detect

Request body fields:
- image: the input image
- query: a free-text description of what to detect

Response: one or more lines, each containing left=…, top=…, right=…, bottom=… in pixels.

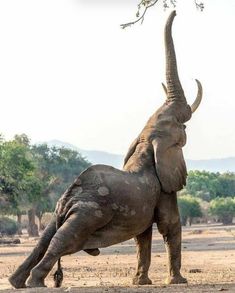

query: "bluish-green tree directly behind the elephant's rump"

left=32, top=144, right=90, bottom=228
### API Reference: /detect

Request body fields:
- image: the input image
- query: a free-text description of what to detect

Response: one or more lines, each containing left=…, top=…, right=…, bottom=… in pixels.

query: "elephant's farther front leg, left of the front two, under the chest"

left=133, top=226, right=152, bottom=285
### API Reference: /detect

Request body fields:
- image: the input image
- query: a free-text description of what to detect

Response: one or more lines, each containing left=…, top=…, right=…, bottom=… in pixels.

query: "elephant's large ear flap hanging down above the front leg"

left=152, top=139, right=187, bottom=193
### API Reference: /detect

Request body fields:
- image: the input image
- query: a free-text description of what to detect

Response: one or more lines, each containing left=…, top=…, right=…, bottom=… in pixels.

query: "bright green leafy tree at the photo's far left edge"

left=0, top=135, right=39, bottom=232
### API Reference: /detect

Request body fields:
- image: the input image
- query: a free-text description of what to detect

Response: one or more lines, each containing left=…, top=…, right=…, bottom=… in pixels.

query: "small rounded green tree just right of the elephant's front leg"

left=178, top=195, right=202, bottom=226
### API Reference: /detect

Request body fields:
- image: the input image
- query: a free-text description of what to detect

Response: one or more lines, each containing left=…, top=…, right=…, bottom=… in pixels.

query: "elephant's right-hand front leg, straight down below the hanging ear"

left=155, top=193, right=187, bottom=284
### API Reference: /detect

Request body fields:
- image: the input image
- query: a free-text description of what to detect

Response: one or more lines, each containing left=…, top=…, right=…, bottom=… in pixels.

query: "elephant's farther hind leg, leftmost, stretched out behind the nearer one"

left=9, top=219, right=56, bottom=288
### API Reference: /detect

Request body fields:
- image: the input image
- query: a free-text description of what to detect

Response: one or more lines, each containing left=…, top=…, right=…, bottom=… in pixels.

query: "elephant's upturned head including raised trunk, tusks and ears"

left=125, top=11, right=202, bottom=193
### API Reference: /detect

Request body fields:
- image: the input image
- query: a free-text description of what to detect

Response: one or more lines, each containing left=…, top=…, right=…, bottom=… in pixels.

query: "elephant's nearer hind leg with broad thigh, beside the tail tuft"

left=27, top=210, right=110, bottom=287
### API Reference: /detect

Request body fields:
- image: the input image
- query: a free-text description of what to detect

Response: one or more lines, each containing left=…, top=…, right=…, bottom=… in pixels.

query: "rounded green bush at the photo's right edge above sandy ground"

left=209, top=197, right=235, bottom=225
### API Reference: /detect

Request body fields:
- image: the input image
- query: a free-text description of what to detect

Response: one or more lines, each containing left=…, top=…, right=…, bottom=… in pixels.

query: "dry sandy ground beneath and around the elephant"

left=0, top=225, right=235, bottom=293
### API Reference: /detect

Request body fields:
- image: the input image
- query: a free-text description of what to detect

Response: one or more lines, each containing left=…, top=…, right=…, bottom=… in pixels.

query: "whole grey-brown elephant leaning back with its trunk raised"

left=9, top=11, right=202, bottom=288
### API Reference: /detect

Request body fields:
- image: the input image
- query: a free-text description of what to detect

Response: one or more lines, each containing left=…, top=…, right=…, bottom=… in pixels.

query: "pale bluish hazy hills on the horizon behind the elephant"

left=46, top=140, right=235, bottom=172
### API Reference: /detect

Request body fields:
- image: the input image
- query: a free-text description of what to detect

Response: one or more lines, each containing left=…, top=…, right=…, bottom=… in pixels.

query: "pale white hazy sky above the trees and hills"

left=0, top=0, right=235, bottom=159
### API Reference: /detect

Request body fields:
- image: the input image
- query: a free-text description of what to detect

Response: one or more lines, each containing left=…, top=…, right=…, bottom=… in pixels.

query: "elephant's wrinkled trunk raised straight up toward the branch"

left=165, top=11, right=186, bottom=102
